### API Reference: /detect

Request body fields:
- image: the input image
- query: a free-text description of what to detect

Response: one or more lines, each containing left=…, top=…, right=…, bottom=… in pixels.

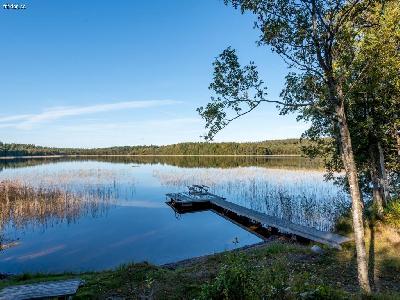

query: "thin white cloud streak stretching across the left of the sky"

left=0, top=100, right=180, bottom=129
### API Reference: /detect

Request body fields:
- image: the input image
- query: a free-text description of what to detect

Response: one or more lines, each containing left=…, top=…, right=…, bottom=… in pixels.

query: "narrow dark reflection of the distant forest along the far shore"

left=0, top=156, right=322, bottom=170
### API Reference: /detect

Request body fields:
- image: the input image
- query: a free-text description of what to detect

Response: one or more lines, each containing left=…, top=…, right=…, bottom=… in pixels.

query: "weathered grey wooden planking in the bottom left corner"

left=0, top=279, right=83, bottom=300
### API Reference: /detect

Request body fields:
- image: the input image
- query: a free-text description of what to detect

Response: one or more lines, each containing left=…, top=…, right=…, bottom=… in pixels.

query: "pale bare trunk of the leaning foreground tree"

left=336, top=87, right=371, bottom=295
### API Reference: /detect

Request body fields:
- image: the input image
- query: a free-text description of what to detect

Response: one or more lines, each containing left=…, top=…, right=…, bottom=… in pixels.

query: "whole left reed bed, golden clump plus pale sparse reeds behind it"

left=0, top=163, right=136, bottom=249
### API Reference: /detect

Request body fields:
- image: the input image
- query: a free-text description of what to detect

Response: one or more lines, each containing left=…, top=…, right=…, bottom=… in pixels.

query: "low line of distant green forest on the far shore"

left=0, top=139, right=307, bottom=157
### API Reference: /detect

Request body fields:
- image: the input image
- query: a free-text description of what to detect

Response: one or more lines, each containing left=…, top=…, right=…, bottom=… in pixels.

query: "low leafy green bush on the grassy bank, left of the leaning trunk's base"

left=200, top=254, right=349, bottom=300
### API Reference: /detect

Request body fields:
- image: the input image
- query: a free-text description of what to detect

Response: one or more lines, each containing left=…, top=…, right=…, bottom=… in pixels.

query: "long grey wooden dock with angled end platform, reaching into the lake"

left=166, top=191, right=350, bottom=249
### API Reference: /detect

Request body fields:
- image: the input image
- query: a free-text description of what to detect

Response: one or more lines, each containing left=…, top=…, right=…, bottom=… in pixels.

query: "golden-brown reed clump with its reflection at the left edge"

left=0, top=180, right=113, bottom=248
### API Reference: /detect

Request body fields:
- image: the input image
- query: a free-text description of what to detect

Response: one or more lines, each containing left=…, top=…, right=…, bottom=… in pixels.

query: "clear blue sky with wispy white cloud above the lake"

left=0, top=0, right=306, bottom=147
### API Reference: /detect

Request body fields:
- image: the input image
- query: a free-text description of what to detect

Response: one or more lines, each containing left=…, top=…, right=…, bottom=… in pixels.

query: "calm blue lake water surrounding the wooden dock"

left=0, top=157, right=349, bottom=273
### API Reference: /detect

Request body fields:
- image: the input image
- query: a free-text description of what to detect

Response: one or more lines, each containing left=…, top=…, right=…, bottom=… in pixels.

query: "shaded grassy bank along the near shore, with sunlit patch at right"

left=0, top=223, right=400, bottom=299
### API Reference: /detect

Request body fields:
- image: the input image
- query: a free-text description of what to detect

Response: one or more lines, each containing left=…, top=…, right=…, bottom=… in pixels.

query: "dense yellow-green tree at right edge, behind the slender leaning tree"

left=347, top=0, right=400, bottom=213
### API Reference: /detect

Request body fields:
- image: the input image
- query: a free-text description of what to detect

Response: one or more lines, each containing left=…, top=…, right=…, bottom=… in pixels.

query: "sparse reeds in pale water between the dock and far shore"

left=154, top=168, right=349, bottom=231
